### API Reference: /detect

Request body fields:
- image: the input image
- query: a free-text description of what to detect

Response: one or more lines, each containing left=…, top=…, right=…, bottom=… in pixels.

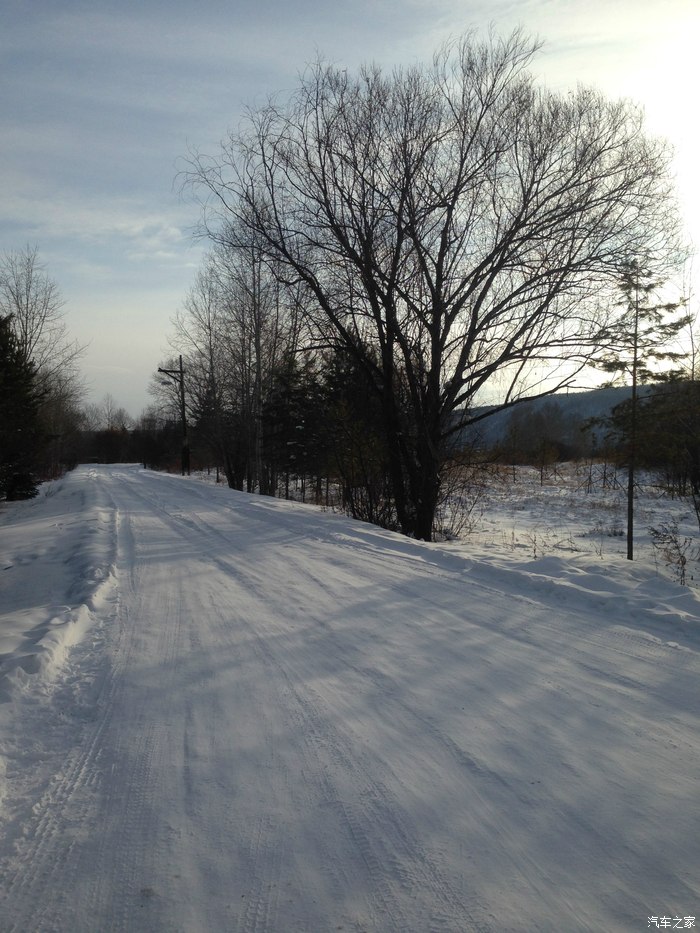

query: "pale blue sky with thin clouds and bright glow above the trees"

left=0, top=0, right=700, bottom=417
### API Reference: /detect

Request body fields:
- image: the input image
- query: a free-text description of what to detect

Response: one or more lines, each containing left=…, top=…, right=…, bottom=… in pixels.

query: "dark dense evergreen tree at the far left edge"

left=0, top=316, right=43, bottom=499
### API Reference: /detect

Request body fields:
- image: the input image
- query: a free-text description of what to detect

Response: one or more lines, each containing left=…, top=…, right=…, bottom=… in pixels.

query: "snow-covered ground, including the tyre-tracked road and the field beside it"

left=0, top=466, right=700, bottom=933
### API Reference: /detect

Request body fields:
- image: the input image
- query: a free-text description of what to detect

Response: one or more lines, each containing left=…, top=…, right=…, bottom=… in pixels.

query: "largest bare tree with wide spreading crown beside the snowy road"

left=190, top=31, right=675, bottom=539
